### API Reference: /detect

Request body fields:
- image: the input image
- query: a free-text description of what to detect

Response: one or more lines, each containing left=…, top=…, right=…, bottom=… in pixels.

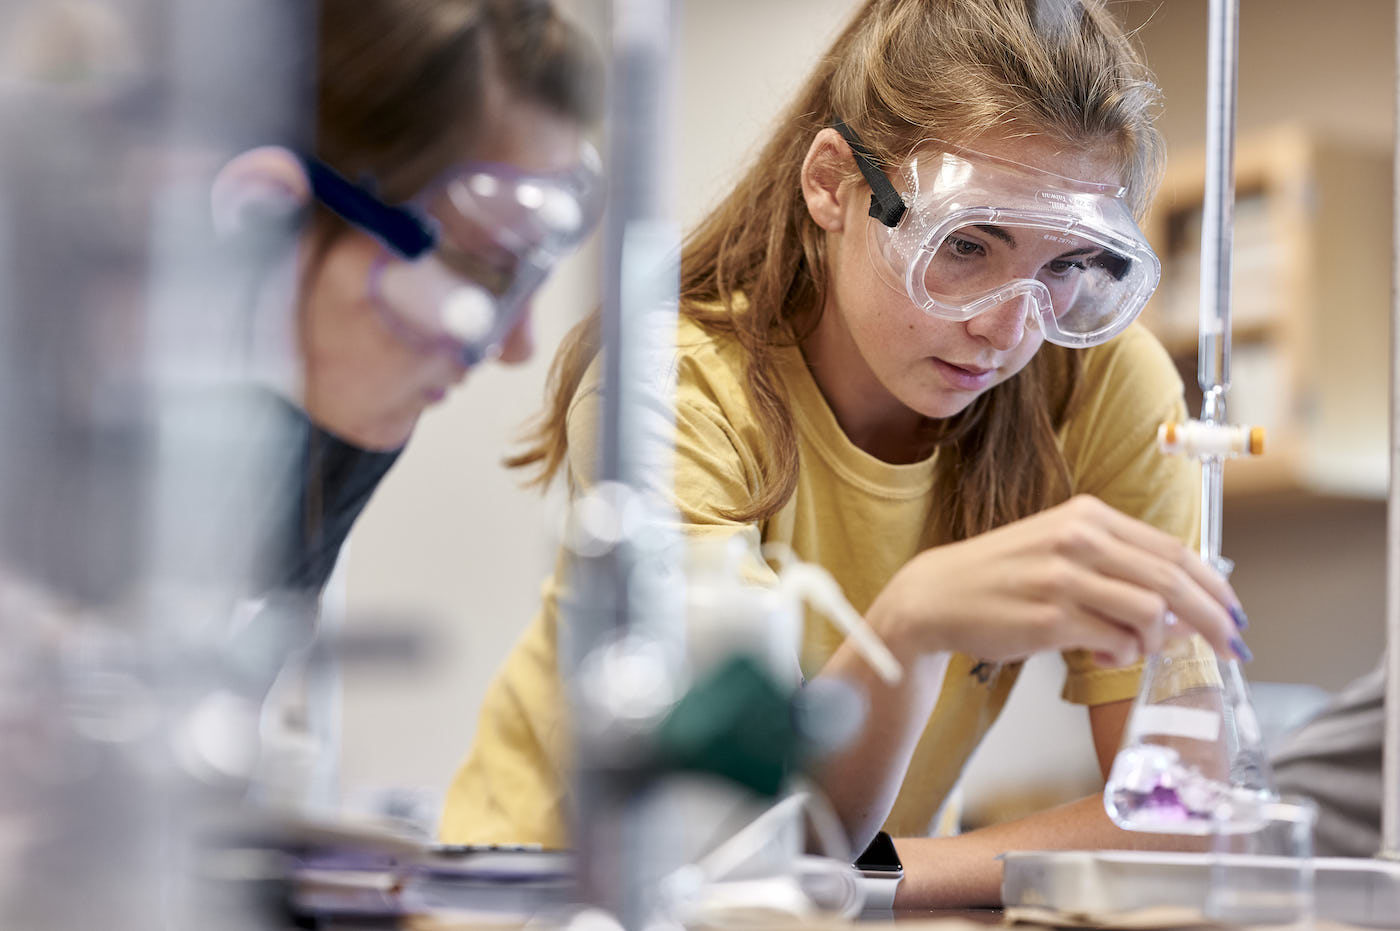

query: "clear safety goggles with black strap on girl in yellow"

left=836, top=123, right=1162, bottom=347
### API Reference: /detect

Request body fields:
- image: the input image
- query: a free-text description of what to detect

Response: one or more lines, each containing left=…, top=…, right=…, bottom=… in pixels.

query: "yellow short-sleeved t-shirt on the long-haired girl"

left=441, top=319, right=1198, bottom=847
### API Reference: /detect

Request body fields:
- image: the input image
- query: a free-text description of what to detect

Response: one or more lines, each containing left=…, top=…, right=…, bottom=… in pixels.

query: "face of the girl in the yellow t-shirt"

left=804, top=136, right=1120, bottom=448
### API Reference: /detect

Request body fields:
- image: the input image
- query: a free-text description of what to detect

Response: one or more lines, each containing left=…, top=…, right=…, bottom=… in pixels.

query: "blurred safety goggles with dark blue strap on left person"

left=308, top=144, right=603, bottom=365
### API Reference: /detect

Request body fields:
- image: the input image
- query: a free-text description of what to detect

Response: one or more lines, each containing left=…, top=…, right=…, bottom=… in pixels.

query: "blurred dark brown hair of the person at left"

left=309, top=0, right=602, bottom=266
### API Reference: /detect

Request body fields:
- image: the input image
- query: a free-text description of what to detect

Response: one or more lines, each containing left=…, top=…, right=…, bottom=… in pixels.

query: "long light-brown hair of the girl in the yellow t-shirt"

left=508, top=0, right=1162, bottom=539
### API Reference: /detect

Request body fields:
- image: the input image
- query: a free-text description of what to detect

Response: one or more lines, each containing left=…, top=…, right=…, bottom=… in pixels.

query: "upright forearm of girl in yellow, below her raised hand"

left=818, top=644, right=948, bottom=847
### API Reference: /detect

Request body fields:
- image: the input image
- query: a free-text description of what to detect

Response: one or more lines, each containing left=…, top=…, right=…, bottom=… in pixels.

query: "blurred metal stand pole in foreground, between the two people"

left=560, top=0, right=680, bottom=928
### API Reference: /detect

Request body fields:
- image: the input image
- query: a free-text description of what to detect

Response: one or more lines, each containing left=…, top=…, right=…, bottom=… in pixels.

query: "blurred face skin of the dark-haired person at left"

left=301, top=90, right=582, bottom=449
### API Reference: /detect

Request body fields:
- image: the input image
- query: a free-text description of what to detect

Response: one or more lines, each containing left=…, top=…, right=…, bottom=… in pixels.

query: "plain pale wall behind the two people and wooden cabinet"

left=333, top=0, right=1394, bottom=828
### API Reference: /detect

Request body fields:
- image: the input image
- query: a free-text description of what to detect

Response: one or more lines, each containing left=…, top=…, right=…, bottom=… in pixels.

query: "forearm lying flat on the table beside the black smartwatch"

left=895, top=795, right=1198, bottom=909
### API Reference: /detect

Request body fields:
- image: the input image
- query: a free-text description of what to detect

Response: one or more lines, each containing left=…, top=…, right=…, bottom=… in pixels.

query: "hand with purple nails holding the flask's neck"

left=868, top=496, right=1249, bottom=665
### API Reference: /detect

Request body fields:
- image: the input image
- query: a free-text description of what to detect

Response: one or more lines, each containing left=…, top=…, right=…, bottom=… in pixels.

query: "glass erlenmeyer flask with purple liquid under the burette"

left=1103, top=636, right=1277, bottom=834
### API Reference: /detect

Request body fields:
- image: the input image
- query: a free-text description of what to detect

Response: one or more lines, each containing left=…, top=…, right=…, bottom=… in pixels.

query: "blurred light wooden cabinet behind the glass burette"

left=1142, top=126, right=1393, bottom=500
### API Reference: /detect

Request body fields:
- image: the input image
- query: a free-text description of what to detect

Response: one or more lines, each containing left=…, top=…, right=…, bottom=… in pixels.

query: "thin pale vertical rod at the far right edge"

left=1380, top=3, right=1400, bottom=860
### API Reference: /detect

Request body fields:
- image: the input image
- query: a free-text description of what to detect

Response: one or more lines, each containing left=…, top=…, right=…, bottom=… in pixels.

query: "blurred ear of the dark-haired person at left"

left=210, top=146, right=311, bottom=237
